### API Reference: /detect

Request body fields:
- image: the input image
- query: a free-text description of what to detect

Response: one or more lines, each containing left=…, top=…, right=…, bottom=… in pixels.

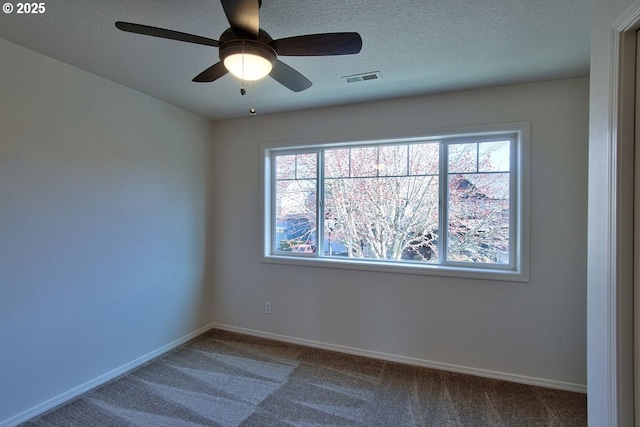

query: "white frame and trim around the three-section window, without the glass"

left=261, top=122, right=530, bottom=282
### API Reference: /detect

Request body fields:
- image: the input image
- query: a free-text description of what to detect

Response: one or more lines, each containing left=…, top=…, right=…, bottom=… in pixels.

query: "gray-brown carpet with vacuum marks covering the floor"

left=22, top=330, right=587, bottom=427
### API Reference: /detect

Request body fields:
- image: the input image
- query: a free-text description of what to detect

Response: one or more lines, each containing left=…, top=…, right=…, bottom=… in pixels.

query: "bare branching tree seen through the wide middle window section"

left=324, top=143, right=439, bottom=261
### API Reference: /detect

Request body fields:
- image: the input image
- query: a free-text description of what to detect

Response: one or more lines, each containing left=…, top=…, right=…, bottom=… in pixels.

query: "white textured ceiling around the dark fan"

left=0, top=0, right=591, bottom=119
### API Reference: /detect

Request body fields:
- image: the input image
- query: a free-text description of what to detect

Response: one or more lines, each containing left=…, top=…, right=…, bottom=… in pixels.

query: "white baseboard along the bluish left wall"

left=0, top=324, right=215, bottom=427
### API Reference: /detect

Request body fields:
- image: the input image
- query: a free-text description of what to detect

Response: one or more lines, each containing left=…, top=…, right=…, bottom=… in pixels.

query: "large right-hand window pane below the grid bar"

left=447, top=173, right=510, bottom=264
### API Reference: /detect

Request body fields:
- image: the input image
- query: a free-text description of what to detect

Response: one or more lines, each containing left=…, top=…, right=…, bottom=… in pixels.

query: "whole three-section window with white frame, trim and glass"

left=264, top=124, right=528, bottom=280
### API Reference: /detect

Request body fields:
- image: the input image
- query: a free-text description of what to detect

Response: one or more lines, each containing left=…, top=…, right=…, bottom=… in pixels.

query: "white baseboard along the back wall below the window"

left=213, top=323, right=587, bottom=394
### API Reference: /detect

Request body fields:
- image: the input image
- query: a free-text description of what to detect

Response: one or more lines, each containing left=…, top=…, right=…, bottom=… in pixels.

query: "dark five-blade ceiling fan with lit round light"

left=115, top=0, right=362, bottom=92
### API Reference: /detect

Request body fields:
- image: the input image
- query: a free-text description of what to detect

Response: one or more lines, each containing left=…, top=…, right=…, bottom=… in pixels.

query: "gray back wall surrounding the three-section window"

left=213, top=78, right=589, bottom=390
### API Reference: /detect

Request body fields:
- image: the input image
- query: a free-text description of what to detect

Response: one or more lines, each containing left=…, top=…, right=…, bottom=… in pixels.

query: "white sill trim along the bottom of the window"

left=262, top=255, right=529, bottom=282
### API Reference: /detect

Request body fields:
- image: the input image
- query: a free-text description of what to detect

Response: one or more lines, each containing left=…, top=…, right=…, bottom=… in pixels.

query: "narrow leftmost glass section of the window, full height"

left=274, top=153, right=317, bottom=253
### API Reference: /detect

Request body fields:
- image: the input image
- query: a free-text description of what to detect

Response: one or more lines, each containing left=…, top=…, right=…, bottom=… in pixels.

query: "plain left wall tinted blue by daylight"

left=0, top=40, right=212, bottom=424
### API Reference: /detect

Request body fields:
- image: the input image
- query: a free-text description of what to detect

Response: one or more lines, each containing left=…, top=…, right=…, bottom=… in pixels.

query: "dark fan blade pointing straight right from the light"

left=274, top=33, right=362, bottom=56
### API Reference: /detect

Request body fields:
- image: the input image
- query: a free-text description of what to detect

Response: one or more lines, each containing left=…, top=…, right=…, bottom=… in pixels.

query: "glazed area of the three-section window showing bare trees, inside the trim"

left=273, top=137, right=513, bottom=265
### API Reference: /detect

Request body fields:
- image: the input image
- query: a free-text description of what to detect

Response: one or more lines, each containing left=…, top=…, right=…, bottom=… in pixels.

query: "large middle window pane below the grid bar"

left=324, top=176, right=438, bottom=262
